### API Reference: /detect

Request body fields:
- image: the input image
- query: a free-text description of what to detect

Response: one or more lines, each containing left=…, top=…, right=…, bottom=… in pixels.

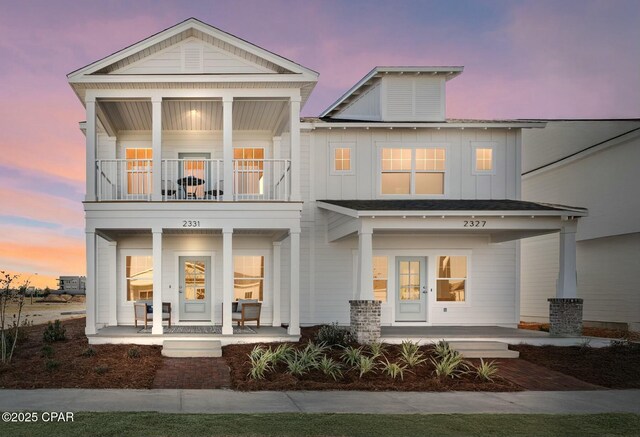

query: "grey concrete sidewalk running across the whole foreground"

left=0, top=389, right=640, bottom=414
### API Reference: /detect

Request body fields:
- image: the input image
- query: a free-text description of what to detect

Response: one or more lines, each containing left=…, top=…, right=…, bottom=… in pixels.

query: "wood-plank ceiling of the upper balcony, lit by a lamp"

left=99, top=99, right=288, bottom=133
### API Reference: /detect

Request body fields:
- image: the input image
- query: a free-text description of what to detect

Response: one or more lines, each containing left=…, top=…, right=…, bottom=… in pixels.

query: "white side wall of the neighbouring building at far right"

left=521, top=121, right=640, bottom=329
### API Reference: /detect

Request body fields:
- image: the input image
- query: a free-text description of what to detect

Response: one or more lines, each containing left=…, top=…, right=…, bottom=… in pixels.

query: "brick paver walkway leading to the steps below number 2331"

left=153, top=358, right=231, bottom=389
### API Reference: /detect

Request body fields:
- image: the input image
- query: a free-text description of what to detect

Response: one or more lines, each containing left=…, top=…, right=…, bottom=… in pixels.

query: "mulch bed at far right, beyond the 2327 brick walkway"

left=509, top=343, right=640, bottom=389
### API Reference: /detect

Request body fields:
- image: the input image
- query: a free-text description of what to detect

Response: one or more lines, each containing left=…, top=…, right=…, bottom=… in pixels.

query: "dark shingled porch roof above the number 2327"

left=318, top=199, right=587, bottom=216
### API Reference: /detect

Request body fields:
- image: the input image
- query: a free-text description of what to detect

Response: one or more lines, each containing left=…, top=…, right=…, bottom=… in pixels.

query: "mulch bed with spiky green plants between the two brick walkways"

left=223, top=340, right=522, bottom=391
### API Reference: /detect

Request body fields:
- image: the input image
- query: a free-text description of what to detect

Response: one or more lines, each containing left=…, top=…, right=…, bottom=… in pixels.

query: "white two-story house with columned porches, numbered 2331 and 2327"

left=68, top=19, right=586, bottom=343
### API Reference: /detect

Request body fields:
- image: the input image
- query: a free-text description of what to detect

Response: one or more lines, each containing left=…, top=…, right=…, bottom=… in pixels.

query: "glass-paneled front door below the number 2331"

left=178, top=256, right=212, bottom=321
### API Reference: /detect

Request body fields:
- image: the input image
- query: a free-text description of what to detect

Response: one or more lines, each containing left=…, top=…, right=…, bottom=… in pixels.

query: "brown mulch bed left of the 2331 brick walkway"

left=0, top=318, right=162, bottom=389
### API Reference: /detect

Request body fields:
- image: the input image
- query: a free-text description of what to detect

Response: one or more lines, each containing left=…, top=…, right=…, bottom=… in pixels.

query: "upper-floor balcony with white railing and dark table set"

left=96, top=159, right=291, bottom=202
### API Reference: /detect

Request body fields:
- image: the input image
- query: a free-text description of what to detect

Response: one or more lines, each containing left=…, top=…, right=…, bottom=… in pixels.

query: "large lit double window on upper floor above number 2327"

left=380, top=148, right=446, bottom=195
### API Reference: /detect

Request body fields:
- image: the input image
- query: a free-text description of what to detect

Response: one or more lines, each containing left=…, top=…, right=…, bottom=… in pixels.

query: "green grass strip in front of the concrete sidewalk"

left=0, top=413, right=640, bottom=437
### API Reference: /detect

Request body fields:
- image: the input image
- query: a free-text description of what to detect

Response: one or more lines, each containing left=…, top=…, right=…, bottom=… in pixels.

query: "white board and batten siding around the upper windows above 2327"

left=311, top=129, right=520, bottom=200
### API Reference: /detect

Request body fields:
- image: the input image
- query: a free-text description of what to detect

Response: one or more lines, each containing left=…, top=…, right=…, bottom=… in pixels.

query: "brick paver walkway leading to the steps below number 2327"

left=498, top=359, right=605, bottom=391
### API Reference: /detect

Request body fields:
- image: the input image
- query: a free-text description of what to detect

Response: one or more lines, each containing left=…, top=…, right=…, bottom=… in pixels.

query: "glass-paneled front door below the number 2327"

left=396, top=257, right=427, bottom=322
